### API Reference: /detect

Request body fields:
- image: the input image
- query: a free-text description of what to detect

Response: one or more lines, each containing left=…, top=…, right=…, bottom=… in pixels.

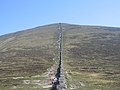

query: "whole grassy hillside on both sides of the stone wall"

left=0, top=23, right=120, bottom=90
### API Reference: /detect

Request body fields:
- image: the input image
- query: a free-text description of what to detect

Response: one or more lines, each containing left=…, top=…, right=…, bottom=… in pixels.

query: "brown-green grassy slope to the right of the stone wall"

left=63, top=25, right=120, bottom=90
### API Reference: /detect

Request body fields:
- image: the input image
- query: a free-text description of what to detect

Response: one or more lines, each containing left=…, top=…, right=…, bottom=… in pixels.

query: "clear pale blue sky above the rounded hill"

left=0, top=0, right=120, bottom=35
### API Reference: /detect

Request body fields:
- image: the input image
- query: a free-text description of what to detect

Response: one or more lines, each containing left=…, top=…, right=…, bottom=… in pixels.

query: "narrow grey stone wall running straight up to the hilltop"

left=51, top=23, right=67, bottom=90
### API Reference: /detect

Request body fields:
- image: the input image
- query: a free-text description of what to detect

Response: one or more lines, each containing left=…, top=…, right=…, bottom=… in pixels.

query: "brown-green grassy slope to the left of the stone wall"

left=0, top=24, right=58, bottom=90
